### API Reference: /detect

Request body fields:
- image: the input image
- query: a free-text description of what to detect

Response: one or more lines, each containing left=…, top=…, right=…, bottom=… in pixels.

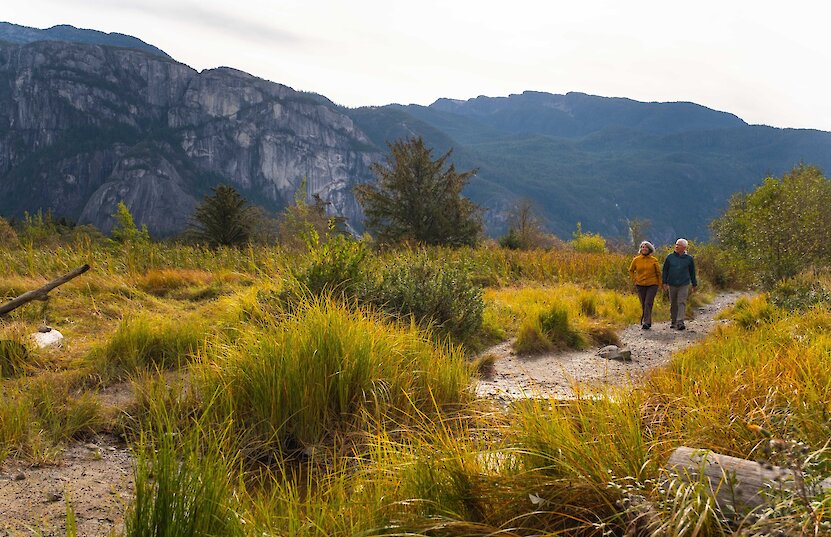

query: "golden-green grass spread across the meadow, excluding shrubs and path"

left=0, top=244, right=831, bottom=536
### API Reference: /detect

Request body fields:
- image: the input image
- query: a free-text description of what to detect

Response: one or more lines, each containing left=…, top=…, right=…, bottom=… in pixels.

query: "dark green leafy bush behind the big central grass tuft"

left=364, top=250, right=485, bottom=341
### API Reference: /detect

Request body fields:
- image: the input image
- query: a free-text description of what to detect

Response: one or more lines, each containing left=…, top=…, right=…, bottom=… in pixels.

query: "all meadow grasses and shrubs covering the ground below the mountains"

left=0, top=162, right=831, bottom=536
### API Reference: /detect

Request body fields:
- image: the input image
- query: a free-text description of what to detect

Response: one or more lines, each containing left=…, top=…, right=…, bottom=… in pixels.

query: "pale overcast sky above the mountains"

left=6, top=0, right=831, bottom=131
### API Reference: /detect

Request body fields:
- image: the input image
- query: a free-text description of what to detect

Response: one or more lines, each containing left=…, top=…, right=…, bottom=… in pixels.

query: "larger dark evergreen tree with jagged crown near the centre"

left=355, top=138, right=482, bottom=246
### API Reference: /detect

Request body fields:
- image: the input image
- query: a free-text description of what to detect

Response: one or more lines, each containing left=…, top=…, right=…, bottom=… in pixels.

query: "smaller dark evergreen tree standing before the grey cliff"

left=189, top=185, right=256, bottom=248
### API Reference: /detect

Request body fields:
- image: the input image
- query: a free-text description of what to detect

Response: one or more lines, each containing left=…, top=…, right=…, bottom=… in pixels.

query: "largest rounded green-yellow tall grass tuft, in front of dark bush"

left=205, top=299, right=471, bottom=456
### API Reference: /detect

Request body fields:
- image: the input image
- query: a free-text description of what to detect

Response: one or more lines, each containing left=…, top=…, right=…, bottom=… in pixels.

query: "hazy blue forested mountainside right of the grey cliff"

left=347, top=92, right=831, bottom=241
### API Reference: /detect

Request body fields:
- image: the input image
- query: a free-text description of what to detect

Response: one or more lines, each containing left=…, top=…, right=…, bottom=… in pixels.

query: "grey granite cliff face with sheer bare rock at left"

left=0, top=41, right=381, bottom=235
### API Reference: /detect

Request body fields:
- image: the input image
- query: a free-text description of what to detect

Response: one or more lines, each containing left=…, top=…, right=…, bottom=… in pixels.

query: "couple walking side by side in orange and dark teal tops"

left=629, top=239, right=698, bottom=330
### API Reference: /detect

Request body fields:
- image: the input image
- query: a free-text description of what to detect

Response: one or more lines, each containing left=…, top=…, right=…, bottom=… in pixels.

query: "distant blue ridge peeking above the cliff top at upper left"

left=0, top=22, right=170, bottom=58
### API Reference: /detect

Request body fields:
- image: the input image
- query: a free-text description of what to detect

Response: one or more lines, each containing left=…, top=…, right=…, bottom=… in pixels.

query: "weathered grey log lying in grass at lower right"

left=666, top=446, right=831, bottom=512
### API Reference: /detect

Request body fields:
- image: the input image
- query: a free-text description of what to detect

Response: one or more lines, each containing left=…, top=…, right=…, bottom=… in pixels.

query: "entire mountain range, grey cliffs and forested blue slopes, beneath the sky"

left=0, top=23, right=831, bottom=241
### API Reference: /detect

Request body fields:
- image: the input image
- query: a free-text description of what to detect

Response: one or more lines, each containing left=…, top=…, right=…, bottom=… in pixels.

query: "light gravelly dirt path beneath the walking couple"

left=476, top=292, right=743, bottom=400
